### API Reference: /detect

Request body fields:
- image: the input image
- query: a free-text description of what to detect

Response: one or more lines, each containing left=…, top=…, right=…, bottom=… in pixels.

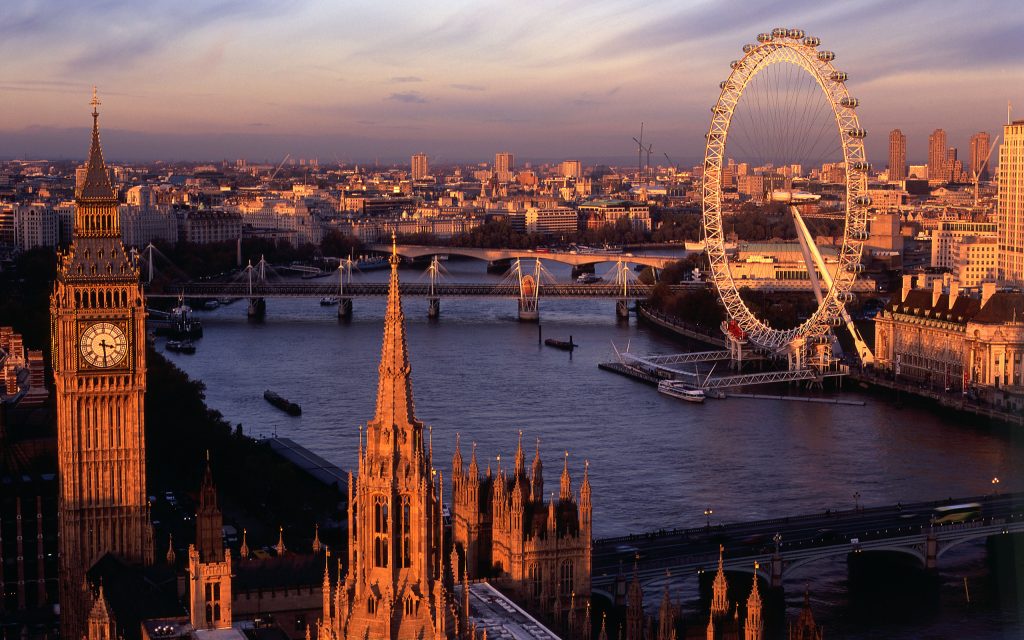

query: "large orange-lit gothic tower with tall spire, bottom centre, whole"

left=318, top=238, right=454, bottom=640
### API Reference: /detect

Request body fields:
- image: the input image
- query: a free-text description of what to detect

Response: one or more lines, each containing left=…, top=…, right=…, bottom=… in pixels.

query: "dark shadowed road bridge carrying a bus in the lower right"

left=592, top=493, right=1024, bottom=599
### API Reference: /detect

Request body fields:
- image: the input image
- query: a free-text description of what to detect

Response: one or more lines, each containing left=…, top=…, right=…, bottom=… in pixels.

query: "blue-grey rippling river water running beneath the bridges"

left=158, top=260, right=1024, bottom=638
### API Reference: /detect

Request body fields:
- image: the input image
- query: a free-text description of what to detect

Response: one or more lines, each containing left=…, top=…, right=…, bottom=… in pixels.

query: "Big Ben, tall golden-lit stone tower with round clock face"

left=50, top=90, right=153, bottom=638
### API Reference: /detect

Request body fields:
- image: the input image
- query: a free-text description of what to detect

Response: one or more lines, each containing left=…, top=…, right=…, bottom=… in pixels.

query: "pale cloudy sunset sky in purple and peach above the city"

left=0, top=0, right=1024, bottom=166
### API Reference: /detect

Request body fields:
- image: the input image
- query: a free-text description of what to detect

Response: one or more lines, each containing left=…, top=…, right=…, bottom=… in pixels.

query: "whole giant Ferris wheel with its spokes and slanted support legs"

left=702, top=28, right=871, bottom=360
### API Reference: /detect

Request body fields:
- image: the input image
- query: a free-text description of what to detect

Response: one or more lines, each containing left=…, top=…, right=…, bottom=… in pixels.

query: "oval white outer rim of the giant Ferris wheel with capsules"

left=701, top=29, right=870, bottom=350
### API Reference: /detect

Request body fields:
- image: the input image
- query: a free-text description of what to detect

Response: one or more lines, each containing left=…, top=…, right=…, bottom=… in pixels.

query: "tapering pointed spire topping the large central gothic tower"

left=373, top=234, right=418, bottom=427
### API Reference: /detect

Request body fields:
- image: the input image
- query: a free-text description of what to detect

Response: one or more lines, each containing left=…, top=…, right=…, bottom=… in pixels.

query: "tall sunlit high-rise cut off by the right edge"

left=996, top=120, right=1024, bottom=286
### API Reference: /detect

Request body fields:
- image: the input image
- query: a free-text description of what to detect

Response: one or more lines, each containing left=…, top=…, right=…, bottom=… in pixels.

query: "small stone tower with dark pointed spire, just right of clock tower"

left=188, top=458, right=231, bottom=629
